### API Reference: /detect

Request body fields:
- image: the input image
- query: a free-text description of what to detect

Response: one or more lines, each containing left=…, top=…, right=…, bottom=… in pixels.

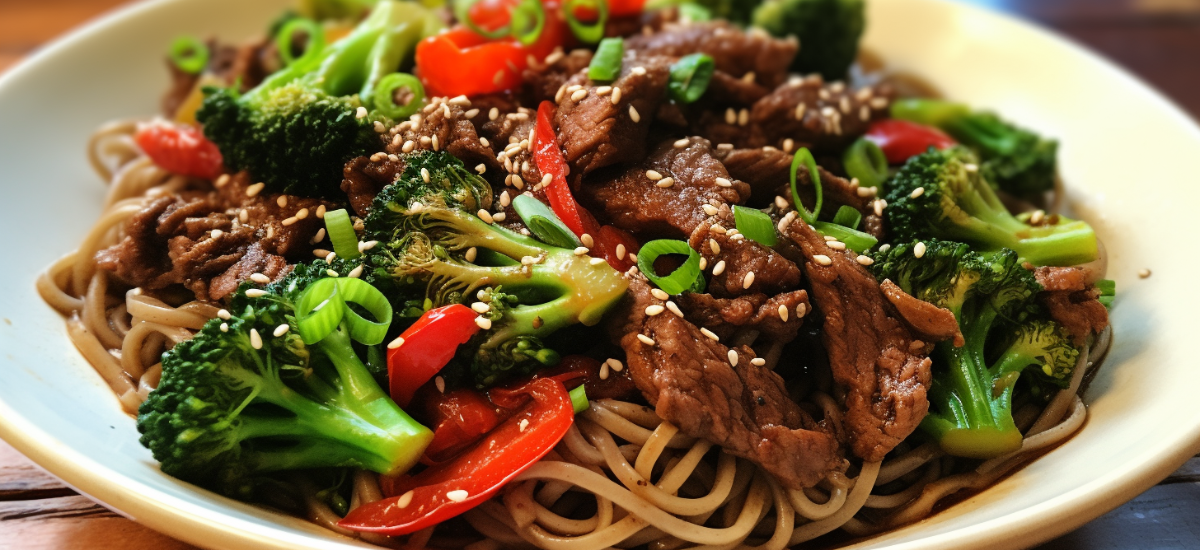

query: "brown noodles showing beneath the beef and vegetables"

left=37, top=121, right=1110, bottom=550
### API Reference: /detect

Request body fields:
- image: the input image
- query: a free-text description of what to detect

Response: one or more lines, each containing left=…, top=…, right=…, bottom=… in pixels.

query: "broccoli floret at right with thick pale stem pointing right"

left=884, top=147, right=1097, bottom=265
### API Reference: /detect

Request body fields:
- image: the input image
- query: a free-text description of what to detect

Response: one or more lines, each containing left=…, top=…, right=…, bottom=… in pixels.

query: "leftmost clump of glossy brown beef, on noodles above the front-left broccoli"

left=96, top=173, right=337, bottom=300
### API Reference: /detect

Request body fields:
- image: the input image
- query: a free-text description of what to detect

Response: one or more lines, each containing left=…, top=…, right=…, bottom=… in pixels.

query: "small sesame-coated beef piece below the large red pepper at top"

left=386, top=97, right=499, bottom=169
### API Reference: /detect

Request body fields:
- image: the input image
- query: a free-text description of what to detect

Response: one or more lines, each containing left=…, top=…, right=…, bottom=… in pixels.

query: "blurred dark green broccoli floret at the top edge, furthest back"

left=752, top=0, right=866, bottom=80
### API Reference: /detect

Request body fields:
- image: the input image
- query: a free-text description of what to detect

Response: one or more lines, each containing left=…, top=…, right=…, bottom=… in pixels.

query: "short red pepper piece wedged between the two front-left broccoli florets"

left=388, top=304, right=480, bottom=407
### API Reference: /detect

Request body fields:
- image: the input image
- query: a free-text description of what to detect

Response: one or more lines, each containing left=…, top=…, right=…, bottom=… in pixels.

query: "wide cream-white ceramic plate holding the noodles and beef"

left=0, top=0, right=1200, bottom=550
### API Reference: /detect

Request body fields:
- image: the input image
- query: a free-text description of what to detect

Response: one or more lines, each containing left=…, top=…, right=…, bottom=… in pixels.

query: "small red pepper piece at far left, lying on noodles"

left=133, top=120, right=224, bottom=179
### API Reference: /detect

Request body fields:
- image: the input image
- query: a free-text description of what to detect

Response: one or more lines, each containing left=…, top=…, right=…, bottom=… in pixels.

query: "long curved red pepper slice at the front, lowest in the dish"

left=337, top=378, right=575, bottom=536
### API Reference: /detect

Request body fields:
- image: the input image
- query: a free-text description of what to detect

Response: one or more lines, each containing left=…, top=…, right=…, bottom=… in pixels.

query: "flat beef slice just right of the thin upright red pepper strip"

left=580, top=138, right=749, bottom=238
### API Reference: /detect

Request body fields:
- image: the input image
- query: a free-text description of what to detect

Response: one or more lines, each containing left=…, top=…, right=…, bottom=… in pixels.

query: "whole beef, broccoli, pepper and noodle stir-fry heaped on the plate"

left=38, top=0, right=1115, bottom=550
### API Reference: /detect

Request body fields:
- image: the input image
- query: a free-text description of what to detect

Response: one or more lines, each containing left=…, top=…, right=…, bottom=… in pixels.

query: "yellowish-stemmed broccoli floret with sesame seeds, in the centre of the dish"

left=366, top=151, right=628, bottom=387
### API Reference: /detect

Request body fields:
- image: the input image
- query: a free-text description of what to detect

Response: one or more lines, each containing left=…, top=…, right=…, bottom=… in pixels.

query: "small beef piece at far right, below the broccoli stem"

left=1033, top=267, right=1109, bottom=346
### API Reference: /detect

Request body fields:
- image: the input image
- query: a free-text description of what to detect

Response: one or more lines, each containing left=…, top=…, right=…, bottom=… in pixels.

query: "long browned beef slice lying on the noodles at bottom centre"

left=616, top=276, right=845, bottom=489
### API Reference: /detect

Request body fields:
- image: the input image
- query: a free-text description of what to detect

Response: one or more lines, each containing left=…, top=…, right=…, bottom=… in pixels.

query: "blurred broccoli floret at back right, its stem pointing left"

left=892, top=98, right=1058, bottom=198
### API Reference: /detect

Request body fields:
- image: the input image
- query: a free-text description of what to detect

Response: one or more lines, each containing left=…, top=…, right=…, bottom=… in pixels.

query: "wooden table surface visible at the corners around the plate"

left=0, top=0, right=1200, bottom=550
